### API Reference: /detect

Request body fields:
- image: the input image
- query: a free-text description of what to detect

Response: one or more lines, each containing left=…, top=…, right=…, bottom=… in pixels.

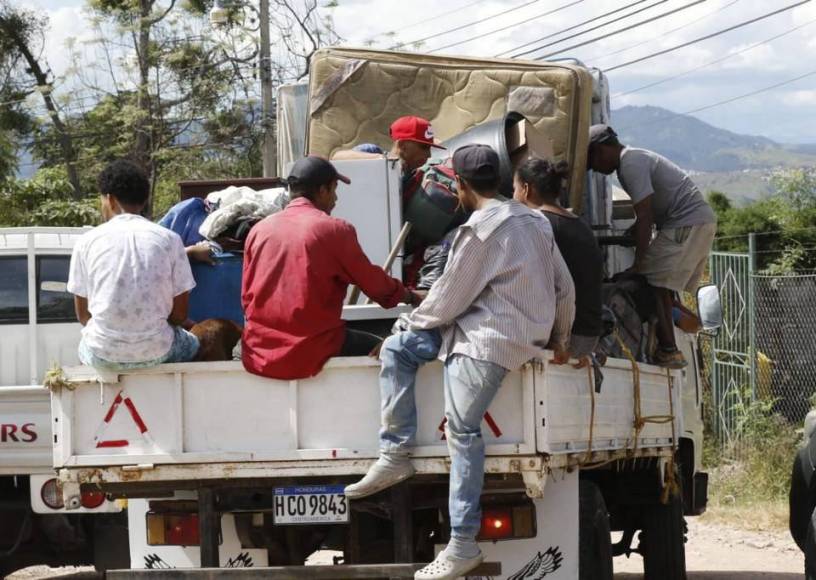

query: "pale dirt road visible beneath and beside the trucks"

left=9, top=518, right=804, bottom=580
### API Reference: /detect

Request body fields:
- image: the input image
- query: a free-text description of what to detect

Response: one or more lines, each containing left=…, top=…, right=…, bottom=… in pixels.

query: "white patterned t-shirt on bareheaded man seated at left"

left=68, top=214, right=195, bottom=362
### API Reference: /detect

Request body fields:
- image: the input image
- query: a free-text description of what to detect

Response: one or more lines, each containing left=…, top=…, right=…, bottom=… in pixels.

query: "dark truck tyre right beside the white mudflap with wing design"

left=578, top=480, right=612, bottom=580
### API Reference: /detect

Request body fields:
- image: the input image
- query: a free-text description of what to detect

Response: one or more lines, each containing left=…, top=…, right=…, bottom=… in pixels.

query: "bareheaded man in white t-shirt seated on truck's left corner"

left=68, top=160, right=199, bottom=369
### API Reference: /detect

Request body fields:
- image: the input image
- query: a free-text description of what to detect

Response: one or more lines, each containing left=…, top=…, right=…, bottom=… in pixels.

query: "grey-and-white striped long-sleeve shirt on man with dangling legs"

left=409, top=200, right=575, bottom=370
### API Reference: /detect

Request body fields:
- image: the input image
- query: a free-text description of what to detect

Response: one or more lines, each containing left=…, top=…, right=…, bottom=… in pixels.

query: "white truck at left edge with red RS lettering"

left=0, top=228, right=127, bottom=576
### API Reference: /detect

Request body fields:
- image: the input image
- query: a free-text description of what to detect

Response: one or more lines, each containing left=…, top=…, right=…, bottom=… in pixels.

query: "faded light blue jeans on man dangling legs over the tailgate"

left=380, top=331, right=507, bottom=544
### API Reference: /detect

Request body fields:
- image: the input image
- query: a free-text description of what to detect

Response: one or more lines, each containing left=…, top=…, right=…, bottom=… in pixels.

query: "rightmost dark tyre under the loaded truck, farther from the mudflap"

left=640, top=493, right=686, bottom=580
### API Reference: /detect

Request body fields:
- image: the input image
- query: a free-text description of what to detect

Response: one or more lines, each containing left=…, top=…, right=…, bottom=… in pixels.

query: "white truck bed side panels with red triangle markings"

left=47, top=357, right=683, bottom=495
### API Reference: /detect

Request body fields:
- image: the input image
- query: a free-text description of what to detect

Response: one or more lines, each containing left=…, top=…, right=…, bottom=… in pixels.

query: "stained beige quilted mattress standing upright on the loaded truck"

left=306, top=48, right=593, bottom=212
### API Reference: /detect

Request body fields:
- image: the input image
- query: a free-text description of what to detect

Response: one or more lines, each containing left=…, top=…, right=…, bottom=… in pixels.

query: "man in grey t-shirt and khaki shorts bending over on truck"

left=587, top=125, right=717, bottom=368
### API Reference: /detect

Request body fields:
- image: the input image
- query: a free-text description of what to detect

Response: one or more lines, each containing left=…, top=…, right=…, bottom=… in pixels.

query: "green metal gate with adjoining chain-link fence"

left=705, top=238, right=816, bottom=456
